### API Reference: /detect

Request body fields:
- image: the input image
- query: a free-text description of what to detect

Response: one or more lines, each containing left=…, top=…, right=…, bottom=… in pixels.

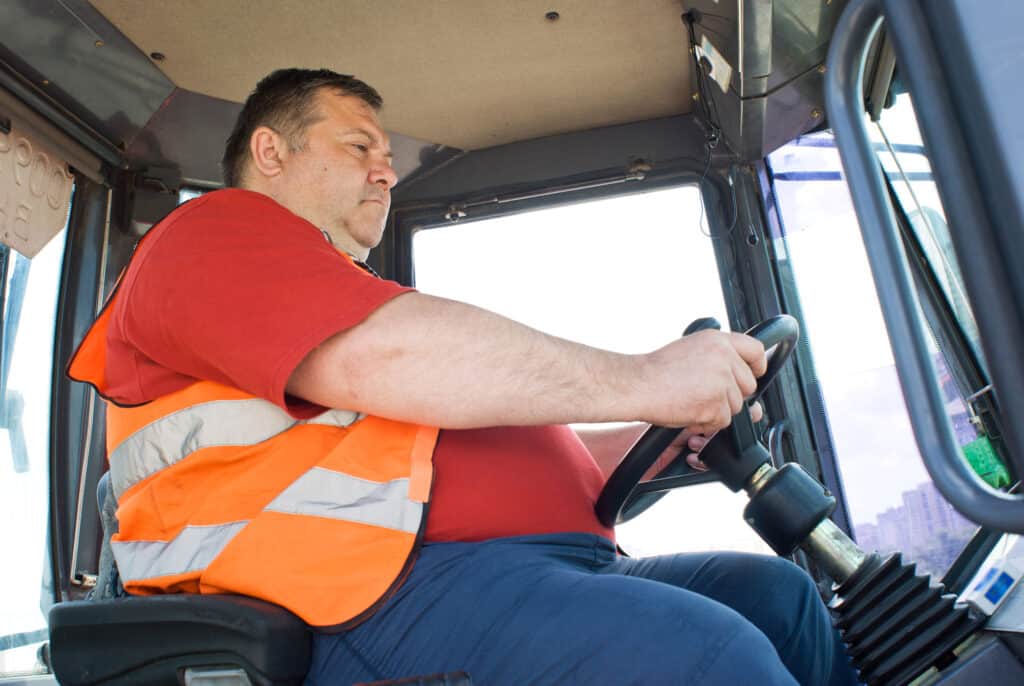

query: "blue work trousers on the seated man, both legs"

left=307, top=533, right=857, bottom=686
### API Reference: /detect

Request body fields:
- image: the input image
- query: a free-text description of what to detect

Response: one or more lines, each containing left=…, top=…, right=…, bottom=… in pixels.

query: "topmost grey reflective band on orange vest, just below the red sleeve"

left=110, top=398, right=361, bottom=500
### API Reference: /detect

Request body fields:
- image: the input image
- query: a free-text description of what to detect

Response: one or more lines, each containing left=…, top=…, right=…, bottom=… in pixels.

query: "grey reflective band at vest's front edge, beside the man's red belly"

left=264, top=467, right=423, bottom=533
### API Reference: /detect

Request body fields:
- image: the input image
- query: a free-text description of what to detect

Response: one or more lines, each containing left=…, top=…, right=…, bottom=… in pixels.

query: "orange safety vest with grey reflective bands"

left=68, top=282, right=438, bottom=629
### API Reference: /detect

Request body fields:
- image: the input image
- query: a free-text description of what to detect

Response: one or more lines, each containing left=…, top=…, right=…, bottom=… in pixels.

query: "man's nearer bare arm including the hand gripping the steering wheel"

left=288, top=293, right=765, bottom=433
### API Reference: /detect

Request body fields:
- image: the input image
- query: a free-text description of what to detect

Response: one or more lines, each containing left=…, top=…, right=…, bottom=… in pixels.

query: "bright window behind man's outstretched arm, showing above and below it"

left=413, top=185, right=770, bottom=555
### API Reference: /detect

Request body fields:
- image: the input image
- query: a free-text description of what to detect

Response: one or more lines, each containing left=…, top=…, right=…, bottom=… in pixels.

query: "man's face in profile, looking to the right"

left=281, top=90, right=398, bottom=259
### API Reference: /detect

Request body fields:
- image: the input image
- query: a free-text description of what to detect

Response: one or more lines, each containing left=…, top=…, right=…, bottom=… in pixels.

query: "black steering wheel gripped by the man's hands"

left=594, top=314, right=800, bottom=527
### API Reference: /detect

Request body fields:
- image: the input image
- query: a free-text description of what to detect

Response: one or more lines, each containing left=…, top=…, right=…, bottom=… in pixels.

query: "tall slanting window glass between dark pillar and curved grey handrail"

left=769, top=132, right=977, bottom=575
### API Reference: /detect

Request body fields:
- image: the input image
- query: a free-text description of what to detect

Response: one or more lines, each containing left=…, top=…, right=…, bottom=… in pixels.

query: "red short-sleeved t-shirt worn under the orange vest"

left=105, top=189, right=612, bottom=541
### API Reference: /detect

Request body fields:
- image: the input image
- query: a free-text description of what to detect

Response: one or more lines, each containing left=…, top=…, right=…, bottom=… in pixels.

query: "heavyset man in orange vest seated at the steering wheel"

left=72, top=70, right=853, bottom=685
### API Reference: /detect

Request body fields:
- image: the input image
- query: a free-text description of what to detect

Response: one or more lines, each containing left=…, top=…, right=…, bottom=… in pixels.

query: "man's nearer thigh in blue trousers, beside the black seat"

left=310, top=535, right=796, bottom=686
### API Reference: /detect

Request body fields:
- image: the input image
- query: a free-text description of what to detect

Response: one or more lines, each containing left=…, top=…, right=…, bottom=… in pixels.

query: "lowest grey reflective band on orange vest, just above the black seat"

left=111, top=521, right=249, bottom=582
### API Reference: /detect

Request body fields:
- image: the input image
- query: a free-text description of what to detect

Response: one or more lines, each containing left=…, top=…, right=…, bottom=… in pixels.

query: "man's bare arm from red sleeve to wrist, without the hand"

left=289, top=293, right=643, bottom=428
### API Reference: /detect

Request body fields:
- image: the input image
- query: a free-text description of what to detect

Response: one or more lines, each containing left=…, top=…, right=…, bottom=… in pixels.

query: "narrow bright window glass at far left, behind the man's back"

left=0, top=228, right=67, bottom=677
